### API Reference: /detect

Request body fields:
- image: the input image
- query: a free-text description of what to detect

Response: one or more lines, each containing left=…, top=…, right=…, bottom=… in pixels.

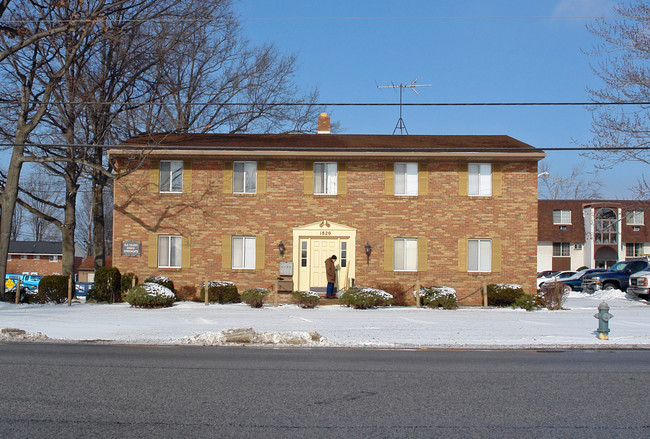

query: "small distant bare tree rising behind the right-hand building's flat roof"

left=538, top=161, right=603, bottom=200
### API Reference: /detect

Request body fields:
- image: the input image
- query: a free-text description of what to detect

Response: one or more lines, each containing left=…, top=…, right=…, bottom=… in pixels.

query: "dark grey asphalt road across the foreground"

left=0, top=344, right=650, bottom=438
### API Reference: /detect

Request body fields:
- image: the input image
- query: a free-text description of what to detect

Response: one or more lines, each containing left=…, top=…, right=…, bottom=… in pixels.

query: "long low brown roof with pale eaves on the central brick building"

left=109, top=134, right=546, bottom=160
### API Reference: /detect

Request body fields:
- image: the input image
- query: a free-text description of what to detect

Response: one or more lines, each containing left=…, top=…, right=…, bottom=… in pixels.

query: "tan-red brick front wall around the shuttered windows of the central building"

left=113, top=158, right=537, bottom=304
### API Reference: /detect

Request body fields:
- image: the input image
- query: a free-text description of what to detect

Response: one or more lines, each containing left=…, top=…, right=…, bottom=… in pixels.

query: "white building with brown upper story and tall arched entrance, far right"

left=537, top=200, right=650, bottom=271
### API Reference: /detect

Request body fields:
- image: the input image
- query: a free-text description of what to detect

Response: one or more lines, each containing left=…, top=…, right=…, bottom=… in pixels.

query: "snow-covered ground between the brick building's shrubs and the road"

left=0, top=291, right=650, bottom=349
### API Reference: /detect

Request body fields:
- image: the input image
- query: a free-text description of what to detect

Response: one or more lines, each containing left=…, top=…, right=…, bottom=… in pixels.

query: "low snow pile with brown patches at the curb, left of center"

left=180, top=328, right=328, bottom=346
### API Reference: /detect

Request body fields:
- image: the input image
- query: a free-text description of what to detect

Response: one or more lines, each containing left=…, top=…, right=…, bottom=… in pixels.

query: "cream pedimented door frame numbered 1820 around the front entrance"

left=293, top=220, right=357, bottom=291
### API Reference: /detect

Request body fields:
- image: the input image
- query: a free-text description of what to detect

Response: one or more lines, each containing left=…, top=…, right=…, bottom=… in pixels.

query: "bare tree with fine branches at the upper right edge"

left=585, top=0, right=650, bottom=198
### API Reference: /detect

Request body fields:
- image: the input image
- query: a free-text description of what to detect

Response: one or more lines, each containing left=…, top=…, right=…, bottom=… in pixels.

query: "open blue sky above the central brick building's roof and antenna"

left=235, top=0, right=644, bottom=198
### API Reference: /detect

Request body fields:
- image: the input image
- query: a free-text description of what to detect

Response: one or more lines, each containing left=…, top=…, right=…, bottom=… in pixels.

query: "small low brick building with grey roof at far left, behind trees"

left=7, top=241, right=63, bottom=276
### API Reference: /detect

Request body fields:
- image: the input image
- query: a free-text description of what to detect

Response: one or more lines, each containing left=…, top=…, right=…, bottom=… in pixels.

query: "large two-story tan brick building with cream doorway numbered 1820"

left=109, top=115, right=545, bottom=304
